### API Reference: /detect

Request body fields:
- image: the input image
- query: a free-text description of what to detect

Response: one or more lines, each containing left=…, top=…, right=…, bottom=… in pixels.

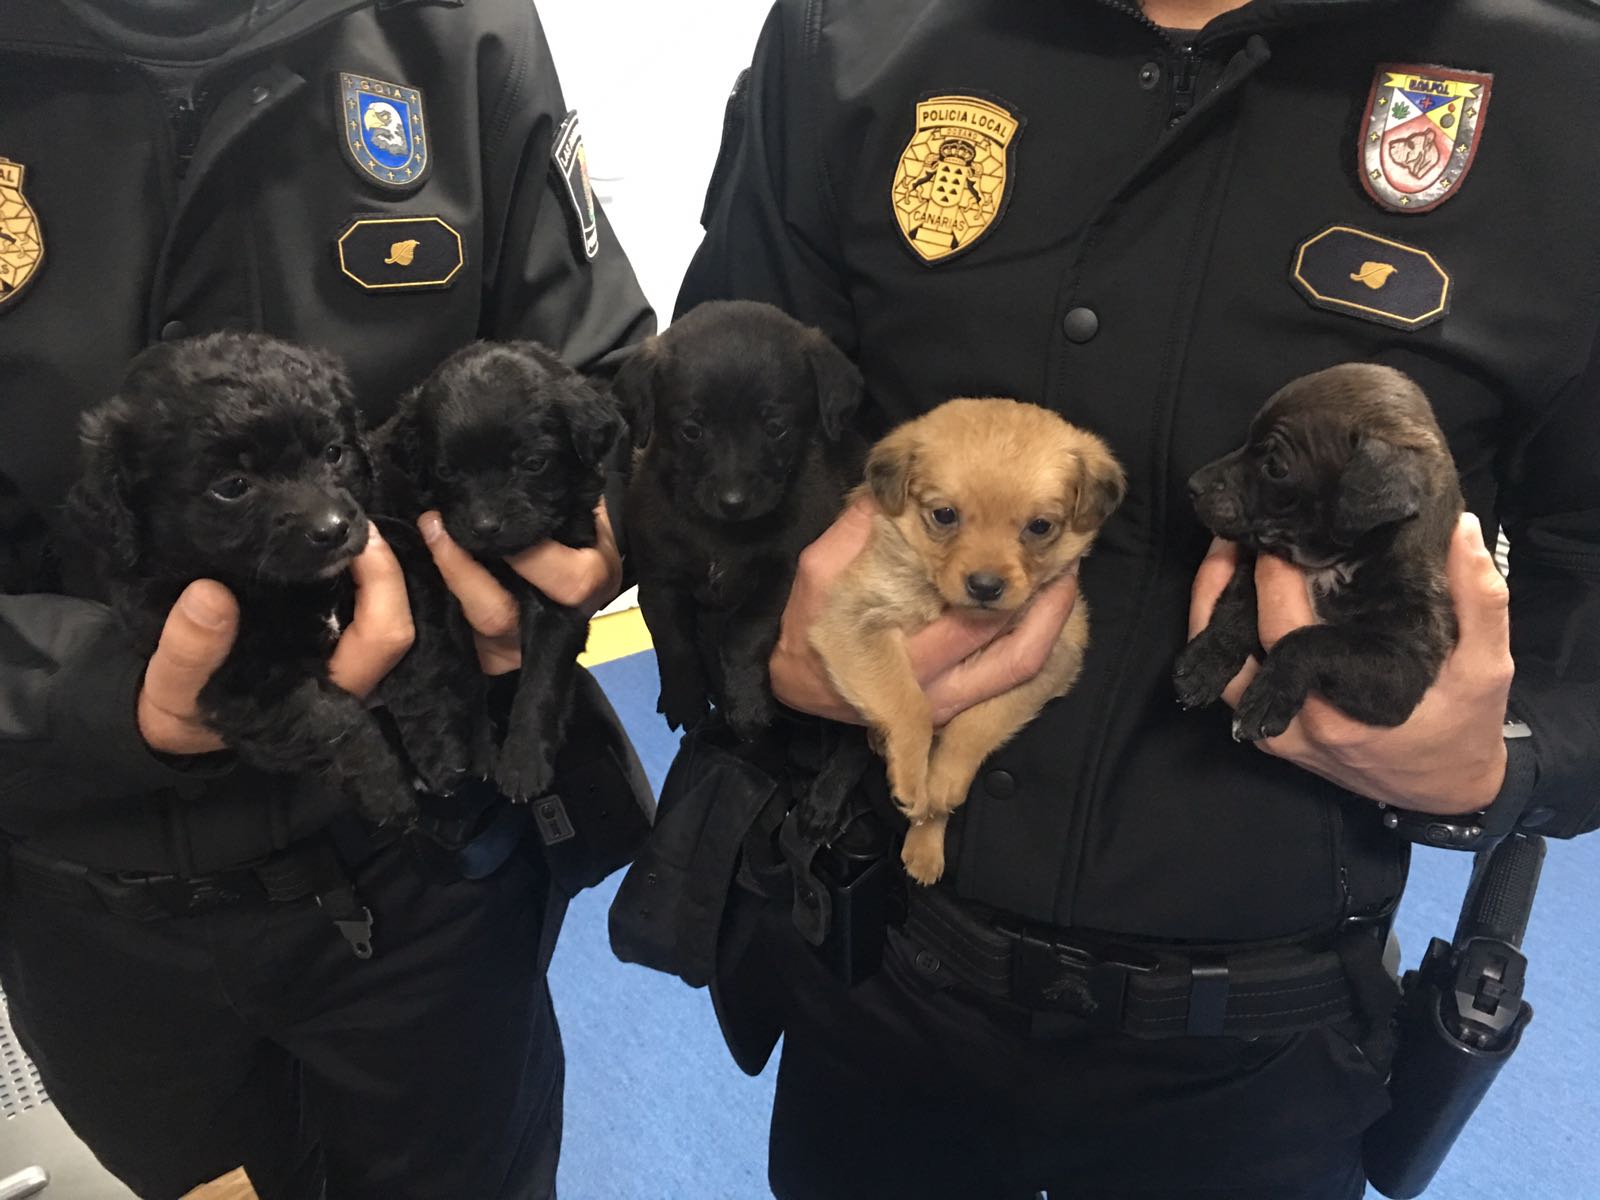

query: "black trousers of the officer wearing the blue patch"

left=0, top=845, right=563, bottom=1200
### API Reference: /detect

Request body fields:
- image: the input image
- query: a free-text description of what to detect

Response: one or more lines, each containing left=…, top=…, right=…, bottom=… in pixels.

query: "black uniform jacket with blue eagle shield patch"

left=0, top=0, right=653, bottom=872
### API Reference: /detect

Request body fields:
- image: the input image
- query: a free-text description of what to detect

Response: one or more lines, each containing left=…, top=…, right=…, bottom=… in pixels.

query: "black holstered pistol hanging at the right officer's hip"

left=1362, top=834, right=1544, bottom=1200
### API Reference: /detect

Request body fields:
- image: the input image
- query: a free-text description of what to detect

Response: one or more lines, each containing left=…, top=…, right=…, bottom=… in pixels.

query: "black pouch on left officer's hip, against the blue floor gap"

left=530, top=667, right=656, bottom=896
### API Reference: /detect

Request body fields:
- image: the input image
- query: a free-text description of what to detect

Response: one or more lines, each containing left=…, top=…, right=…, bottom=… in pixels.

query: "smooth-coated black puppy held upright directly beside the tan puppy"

left=616, top=301, right=866, bottom=738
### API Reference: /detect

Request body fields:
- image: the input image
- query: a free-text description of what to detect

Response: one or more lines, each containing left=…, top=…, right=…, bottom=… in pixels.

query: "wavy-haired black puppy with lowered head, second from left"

left=374, top=341, right=622, bottom=800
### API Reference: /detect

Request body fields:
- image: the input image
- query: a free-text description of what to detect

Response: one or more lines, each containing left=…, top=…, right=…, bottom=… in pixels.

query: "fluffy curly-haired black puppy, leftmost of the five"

left=70, top=333, right=486, bottom=819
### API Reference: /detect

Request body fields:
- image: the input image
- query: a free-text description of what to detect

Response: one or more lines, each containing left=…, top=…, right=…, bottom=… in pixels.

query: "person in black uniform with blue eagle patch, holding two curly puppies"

left=0, top=0, right=653, bottom=1200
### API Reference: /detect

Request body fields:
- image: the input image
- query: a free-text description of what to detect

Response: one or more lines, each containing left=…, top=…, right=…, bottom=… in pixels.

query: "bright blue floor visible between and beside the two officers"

left=550, top=654, right=1600, bottom=1200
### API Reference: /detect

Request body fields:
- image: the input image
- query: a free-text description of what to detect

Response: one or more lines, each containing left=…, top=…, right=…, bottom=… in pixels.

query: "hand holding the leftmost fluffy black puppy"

left=138, top=526, right=414, bottom=755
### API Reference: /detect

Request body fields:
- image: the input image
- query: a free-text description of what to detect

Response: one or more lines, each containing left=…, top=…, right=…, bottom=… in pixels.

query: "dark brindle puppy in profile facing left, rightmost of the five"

left=1173, top=363, right=1462, bottom=741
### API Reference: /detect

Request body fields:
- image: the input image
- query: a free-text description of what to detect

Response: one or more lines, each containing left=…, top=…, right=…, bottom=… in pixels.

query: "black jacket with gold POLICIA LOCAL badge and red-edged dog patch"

left=678, top=0, right=1600, bottom=939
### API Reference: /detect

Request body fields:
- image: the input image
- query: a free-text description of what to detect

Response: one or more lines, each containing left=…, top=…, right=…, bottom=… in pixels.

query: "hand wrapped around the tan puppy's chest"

left=770, top=499, right=1078, bottom=726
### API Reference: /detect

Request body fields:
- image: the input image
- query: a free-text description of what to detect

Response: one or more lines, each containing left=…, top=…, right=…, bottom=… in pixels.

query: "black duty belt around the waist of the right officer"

left=904, top=886, right=1381, bottom=1038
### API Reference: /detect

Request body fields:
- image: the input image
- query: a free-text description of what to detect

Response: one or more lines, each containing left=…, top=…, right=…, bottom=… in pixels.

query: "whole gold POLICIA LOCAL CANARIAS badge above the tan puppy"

left=893, top=96, right=1026, bottom=266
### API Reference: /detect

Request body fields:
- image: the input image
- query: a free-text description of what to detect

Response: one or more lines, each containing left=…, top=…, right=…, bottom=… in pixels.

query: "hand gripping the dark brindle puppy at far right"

left=1189, top=514, right=1512, bottom=814
